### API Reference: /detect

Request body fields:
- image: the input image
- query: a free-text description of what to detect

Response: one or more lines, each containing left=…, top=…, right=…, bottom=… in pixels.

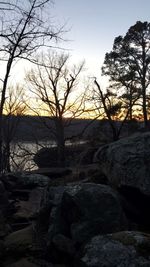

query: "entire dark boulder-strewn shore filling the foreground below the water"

left=0, top=133, right=150, bottom=267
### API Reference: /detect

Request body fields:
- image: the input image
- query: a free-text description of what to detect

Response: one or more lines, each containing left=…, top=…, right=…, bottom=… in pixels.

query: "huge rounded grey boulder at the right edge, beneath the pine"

left=94, top=132, right=150, bottom=195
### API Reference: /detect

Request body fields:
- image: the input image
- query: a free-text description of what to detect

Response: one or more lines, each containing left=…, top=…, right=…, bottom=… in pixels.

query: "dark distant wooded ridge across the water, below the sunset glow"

left=3, top=115, right=143, bottom=142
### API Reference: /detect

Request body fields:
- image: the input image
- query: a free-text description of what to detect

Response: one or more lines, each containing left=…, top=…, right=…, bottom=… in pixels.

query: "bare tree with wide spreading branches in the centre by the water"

left=27, top=53, right=84, bottom=168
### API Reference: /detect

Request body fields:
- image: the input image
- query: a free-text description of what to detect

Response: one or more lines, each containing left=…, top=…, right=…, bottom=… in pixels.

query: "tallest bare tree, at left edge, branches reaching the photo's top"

left=0, top=0, right=62, bottom=171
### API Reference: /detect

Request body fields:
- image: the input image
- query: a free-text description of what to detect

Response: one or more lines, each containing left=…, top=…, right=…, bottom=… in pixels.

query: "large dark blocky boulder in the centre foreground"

left=62, top=183, right=126, bottom=243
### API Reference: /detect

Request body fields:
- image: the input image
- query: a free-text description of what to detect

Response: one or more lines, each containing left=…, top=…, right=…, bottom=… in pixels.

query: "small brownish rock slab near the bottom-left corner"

left=4, top=226, right=33, bottom=255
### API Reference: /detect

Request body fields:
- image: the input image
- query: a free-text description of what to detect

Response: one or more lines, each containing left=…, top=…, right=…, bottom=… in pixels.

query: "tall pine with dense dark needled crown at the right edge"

left=102, top=21, right=150, bottom=127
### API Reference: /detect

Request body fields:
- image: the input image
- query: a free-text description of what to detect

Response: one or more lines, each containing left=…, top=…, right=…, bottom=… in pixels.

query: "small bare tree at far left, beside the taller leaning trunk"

left=2, top=85, right=27, bottom=171
